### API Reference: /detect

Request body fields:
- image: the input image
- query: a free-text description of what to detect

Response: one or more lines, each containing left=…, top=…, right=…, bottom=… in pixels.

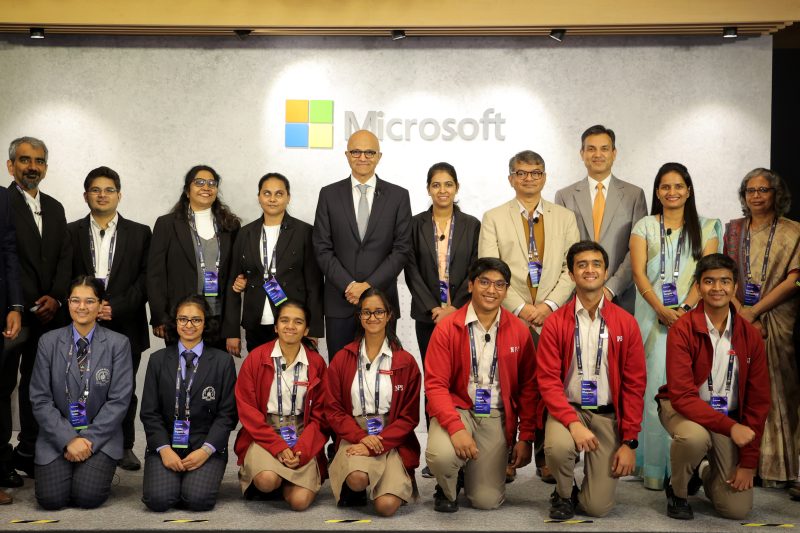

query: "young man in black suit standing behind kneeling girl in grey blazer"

left=67, top=167, right=151, bottom=470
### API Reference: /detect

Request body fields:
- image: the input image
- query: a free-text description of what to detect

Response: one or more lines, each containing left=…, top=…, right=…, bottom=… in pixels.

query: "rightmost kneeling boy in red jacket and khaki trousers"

left=658, top=254, right=770, bottom=520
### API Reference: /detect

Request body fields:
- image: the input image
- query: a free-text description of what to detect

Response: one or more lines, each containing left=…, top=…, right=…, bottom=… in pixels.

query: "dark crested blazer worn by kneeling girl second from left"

left=139, top=344, right=239, bottom=456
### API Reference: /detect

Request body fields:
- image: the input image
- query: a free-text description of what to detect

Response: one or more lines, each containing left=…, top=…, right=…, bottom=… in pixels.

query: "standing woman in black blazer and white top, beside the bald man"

left=223, top=172, right=324, bottom=353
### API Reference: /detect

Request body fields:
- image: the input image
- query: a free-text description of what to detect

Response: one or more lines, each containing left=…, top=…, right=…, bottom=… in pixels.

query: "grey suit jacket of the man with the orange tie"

left=555, top=174, right=647, bottom=314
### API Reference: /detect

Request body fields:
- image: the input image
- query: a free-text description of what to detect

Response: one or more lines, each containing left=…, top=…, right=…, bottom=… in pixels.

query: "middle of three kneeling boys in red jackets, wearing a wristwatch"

left=536, top=240, right=647, bottom=520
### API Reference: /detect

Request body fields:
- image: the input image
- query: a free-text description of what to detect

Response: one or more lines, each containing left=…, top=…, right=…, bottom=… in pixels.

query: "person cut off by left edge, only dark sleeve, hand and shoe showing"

left=0, top=187, right=23, bottom=505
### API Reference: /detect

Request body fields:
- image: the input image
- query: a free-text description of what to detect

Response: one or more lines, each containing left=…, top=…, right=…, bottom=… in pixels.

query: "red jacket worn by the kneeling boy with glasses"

left=425, top=304, right=539, bottom=445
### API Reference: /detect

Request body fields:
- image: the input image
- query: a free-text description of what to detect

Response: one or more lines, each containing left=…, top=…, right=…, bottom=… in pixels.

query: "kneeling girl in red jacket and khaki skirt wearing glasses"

left=325, top=287, right=420, bottom=516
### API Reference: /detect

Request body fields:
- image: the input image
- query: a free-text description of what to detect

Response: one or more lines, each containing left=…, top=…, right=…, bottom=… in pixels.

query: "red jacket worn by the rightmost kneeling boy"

left=657, top=301, right=770, bottom=468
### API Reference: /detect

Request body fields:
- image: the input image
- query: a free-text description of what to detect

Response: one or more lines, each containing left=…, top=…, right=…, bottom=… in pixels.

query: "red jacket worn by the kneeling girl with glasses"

left=325, top=341, right=421, bottom=471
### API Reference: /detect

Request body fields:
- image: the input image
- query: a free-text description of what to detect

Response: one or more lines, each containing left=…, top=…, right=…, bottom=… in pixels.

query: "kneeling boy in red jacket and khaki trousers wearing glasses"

left=425, top=257, right=538, bottom=513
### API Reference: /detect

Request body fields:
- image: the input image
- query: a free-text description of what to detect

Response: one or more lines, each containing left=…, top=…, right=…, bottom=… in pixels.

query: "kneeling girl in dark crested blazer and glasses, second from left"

left=139, top=295, right=239, bottom=512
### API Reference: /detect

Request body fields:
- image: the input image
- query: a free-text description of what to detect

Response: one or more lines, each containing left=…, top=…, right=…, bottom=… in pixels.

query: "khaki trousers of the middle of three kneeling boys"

left=544, top=409, right=620, bottom=517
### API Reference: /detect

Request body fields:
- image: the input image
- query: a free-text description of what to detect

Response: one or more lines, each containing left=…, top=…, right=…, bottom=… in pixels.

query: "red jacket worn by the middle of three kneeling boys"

left=536, top=297, right=647, bottom=440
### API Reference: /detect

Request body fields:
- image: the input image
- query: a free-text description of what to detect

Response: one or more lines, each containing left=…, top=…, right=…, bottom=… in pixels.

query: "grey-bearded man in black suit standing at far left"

left=0, top=137, right=72, bottom=484
